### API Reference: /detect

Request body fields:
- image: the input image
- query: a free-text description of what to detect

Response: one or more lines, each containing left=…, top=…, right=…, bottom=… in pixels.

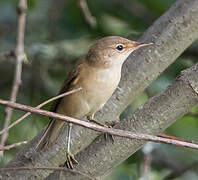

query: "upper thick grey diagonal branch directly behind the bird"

left=3, top=0, right=198, bottom=179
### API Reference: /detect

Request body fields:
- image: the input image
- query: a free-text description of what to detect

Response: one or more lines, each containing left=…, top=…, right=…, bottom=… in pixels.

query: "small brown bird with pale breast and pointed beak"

left=36, top=36, right=152, bottom=168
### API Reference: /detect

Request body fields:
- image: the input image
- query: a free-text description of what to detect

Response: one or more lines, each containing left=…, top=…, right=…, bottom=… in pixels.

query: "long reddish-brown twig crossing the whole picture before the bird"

left=0, top=99, right=198, bottom=149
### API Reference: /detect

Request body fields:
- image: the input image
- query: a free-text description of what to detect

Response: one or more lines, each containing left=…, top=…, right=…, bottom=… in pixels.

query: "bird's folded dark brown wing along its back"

left=50, top=58, right=84, bottom=112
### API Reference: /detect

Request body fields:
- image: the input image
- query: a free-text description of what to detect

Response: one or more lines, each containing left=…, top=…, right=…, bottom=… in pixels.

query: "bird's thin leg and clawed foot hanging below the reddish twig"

left=66, top=123, right=78, bottom=169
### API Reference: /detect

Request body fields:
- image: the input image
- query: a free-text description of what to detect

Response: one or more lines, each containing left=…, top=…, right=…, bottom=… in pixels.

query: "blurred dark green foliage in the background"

left=0, top=0, right=198, bottom=180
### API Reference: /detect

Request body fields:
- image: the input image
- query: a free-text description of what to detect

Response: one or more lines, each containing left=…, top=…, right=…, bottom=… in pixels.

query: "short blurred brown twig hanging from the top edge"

left=78, top=0, right=97, bottom=29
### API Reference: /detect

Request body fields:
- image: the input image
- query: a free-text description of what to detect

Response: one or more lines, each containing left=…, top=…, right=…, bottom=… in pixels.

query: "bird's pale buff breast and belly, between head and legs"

left=57, top=65, right=121, bottom=118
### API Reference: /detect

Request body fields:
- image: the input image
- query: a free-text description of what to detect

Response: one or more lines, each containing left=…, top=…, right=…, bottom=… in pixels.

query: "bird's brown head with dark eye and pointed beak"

left=86, top=36, right=152, bottom=68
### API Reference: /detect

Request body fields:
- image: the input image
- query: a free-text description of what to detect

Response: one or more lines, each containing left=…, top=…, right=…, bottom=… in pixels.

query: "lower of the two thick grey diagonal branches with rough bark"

left=46, top=63, right=198, bottom=180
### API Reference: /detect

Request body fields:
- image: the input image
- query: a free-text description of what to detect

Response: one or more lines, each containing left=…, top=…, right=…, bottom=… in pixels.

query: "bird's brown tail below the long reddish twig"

left=36, top=120, right=64, bottom=151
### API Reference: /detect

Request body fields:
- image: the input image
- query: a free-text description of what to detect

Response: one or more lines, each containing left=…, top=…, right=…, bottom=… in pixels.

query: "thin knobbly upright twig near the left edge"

left=0, top=0, right=27, bottom=147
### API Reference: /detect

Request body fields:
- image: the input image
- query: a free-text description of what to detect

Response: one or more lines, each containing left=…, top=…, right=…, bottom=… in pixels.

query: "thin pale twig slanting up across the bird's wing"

left=0, top=87, right=82, bottom=135
